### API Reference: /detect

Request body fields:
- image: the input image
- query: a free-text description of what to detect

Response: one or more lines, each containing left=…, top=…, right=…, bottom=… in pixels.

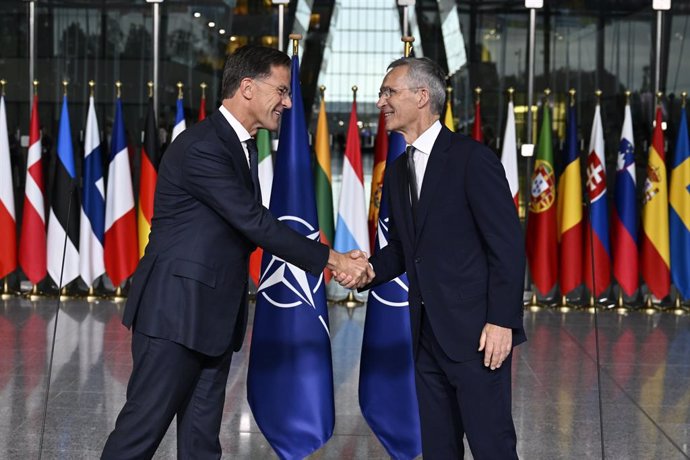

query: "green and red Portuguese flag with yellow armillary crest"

left=527, top=101, right=558, bottom=296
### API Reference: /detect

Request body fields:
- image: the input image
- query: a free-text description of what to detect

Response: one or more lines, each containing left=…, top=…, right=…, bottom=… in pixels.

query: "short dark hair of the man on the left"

left=221, top=45, right=291, bottom=99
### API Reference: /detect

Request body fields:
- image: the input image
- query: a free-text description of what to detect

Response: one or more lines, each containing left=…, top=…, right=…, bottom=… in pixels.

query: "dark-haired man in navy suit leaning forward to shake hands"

left=102, top=47, right=373, bottom=460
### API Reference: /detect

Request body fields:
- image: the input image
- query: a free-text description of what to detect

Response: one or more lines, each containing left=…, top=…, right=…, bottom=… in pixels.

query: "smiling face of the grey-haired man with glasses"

left=376, top=66, right=422, bottom=134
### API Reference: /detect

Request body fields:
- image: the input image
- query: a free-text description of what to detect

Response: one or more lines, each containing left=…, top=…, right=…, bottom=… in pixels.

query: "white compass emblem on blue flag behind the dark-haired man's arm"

left=257, top=216, right=330, bottom=337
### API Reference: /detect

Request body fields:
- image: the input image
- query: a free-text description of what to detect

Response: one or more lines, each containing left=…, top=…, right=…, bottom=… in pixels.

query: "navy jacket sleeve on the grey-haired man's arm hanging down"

left=465, top=147, right=525, bottom=328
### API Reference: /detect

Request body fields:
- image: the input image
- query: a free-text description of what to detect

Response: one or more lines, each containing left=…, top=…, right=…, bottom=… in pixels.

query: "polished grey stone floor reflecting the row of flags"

left=0, top=298, right=690, bottom=460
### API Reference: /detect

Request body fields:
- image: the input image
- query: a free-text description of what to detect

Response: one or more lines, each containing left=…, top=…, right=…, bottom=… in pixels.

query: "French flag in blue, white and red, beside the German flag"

left=105, top=95, right=138, bottom=286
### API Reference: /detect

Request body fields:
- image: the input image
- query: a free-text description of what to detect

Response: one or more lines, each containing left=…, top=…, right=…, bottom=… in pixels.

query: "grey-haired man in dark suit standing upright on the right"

left=362, top=58, right=525, bottom=460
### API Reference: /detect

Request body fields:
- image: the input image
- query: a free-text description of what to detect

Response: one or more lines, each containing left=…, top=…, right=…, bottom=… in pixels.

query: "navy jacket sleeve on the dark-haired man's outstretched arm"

left=182, top=141, right=329, bottom=275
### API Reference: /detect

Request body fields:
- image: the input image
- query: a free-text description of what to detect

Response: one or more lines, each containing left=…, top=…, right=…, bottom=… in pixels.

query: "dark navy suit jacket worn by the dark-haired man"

left=123, top=110, right=328, bottom=356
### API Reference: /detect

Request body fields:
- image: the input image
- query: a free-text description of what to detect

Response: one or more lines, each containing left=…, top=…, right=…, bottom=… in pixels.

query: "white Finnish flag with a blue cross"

left=79, top=96, right=105, bottom=287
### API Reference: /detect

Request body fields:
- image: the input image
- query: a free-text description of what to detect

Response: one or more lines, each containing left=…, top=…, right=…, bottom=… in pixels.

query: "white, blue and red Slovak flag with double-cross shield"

left=582, top=102, right=611, bottom=297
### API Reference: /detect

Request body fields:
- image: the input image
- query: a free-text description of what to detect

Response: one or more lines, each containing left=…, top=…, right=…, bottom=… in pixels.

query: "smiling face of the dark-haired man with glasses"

left=249, top=66, right=292, bottom=135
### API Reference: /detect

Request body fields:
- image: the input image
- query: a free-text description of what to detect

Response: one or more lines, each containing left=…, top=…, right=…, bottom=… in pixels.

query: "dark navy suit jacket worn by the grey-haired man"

left=370, top=127, right=526, bottom=361
